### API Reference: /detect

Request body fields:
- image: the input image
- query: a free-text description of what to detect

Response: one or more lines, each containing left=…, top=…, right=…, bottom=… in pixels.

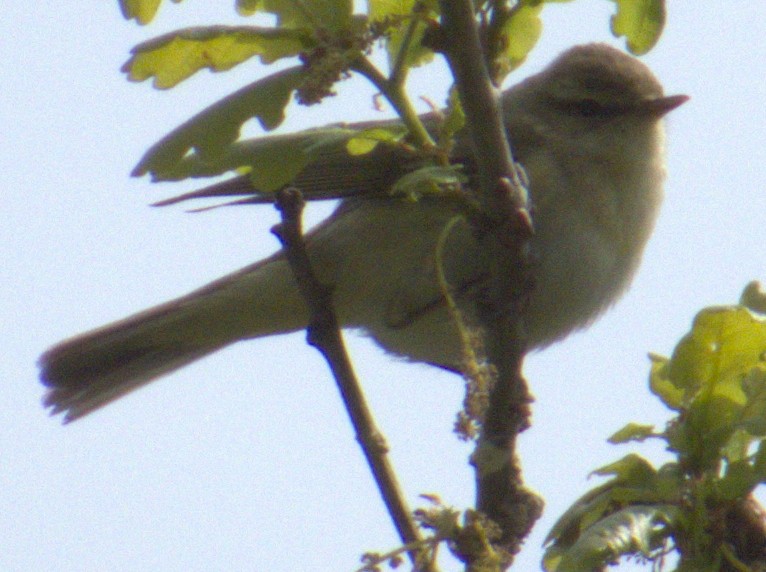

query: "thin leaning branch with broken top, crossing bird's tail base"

left=272, top=188, right=431, bottom=571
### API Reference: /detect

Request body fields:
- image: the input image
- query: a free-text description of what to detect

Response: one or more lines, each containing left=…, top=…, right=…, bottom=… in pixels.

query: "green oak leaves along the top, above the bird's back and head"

left=120, top=0, right=665, bottom=206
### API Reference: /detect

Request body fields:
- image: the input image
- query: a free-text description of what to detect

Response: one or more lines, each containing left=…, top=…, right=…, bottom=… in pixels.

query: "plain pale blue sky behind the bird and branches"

left=0, top=0, right=766, bottom=572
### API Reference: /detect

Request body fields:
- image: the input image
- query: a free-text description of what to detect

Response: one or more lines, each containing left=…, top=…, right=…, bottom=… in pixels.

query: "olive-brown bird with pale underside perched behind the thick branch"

left=39, top=44, right=688, bottom=423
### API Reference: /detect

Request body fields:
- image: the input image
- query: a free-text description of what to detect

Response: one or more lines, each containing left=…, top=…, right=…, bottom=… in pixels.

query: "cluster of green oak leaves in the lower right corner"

left=544, top=285, right=766, bottom=572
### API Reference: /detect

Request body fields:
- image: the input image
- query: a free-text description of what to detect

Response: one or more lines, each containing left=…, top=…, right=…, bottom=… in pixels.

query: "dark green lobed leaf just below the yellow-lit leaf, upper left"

left=131, top=67, right=304, bottom=180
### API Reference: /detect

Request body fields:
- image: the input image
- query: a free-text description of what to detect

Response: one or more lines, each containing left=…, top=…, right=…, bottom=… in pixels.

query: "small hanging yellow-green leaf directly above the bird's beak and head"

left=611, top=0, right=665, bottom=55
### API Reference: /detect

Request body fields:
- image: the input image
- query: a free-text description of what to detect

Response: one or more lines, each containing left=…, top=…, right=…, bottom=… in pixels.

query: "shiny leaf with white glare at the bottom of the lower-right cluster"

left=543, top=505, right=678, bottom=572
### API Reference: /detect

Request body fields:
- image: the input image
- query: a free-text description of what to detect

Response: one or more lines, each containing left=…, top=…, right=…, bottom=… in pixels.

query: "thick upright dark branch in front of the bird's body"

left=439, top=0, right=542, bottom=564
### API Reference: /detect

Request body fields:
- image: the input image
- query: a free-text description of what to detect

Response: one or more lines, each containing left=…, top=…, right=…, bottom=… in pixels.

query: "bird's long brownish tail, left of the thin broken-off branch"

left=40, top=258, right=308, bottom=422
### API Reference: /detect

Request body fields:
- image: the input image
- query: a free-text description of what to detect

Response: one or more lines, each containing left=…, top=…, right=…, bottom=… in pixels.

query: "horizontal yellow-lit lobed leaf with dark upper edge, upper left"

left=122, top=26, right=310, bottom=89
